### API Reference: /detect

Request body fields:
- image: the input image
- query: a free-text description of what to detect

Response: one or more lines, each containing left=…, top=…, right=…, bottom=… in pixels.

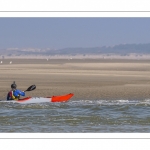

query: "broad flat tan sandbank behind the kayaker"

left=0, top=59, right=150, bottom=100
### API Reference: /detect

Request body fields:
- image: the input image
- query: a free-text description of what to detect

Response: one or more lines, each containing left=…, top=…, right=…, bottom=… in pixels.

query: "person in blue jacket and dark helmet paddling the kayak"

left=7, top=81, right=25, bottom=100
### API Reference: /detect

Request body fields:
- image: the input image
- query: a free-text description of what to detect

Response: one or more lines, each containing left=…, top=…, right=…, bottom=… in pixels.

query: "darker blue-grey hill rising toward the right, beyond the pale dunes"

left=58, top=43, right=150, bottom=55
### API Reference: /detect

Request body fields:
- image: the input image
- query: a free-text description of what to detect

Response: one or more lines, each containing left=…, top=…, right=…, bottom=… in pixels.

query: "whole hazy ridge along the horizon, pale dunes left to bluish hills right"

left=0, top=43, right=150, bottom=56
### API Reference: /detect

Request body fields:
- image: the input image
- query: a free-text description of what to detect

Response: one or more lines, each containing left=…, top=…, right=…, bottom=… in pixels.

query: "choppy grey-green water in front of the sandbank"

left=0, top=99, right=150, bottom=133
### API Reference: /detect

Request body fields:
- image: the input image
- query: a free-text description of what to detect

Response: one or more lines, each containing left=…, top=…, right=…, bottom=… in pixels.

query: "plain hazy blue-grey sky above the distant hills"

left=0, top=18, right=150, bottom=48
